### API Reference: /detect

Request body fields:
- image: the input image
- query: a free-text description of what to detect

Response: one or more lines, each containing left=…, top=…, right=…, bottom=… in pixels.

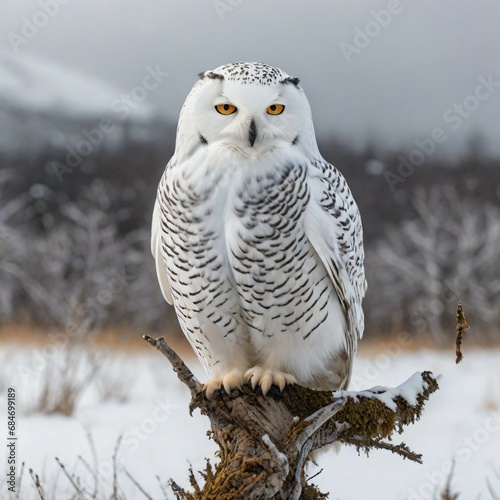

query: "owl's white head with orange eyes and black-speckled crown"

left=176, top=62, right=317, bottom=158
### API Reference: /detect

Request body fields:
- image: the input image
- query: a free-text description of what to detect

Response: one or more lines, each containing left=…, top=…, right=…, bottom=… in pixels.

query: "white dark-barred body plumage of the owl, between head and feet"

left=157, top=152, right=365, bottom=390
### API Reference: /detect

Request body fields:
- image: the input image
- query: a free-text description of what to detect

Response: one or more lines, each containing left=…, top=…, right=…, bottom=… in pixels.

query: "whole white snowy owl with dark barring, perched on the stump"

left=152, top=62, right=366, bottom=398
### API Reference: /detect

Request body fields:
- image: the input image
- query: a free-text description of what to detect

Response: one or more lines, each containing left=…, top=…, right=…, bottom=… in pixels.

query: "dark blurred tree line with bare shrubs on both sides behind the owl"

left=0, top=112, right=500, bottom=342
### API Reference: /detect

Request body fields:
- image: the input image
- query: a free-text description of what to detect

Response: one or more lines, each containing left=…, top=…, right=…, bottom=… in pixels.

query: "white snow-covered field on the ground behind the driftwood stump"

left=0, top=341, right=500, bottom=500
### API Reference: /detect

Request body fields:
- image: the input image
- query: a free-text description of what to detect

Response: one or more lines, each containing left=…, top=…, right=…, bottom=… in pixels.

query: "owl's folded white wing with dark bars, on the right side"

left=305, top=159, right=366, bottom=344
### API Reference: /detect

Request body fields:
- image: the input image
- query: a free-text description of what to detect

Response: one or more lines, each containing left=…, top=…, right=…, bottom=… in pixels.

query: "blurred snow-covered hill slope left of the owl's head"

left=0, top=51, right=160, bottom=154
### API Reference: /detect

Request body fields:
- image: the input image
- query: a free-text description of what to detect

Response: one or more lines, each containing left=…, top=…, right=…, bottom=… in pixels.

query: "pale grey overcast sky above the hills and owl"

left=0, top=0, right=500, bottom=154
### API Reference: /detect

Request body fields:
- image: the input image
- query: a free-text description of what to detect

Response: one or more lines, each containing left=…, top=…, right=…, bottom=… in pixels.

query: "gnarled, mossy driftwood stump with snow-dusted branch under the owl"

left=144, top=336, right=438, bottom=500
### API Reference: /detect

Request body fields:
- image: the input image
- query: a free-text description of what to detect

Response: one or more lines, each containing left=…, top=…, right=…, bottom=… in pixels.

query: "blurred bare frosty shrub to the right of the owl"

left=365, top=186, right=500, bottom=342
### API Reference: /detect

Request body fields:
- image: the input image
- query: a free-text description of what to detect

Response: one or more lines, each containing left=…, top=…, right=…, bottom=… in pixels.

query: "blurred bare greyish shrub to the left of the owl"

left=0, top=180, right=176, bottom=337
